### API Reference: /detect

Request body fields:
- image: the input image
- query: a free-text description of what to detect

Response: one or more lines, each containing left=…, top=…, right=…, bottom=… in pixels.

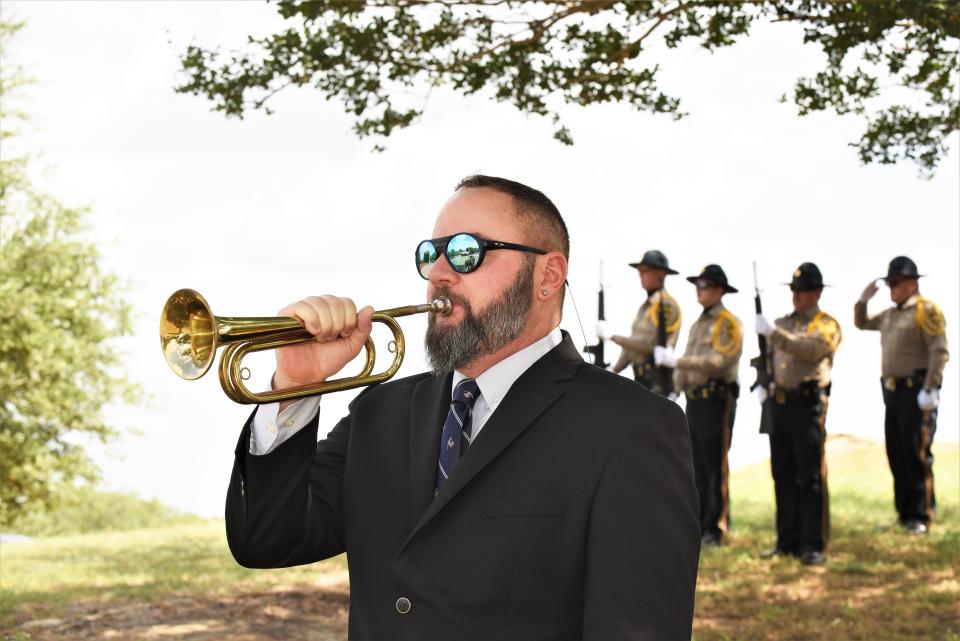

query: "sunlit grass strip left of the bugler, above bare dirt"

left=0, top=519, right=346, bottom=629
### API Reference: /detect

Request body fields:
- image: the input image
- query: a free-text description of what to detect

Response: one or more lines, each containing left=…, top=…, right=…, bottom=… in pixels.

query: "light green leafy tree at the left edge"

left=0, top=23, right=136, bottom=526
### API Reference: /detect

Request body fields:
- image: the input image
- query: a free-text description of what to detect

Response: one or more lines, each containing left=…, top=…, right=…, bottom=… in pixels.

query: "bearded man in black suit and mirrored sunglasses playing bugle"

left=226, top=176, right=700, bottom=641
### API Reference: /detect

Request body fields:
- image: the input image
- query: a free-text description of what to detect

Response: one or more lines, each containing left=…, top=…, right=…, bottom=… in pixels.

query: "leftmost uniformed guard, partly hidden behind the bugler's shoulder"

left=597, top=249, right=682, bottom=398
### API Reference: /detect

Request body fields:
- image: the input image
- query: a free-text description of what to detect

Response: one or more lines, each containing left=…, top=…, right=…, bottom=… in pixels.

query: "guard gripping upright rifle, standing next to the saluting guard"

left=756, top=263, right=842, bottom=565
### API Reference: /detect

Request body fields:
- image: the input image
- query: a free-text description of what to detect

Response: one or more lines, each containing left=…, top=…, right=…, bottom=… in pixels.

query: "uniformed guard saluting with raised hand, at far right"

left=853, top=256, right=950, bottom=534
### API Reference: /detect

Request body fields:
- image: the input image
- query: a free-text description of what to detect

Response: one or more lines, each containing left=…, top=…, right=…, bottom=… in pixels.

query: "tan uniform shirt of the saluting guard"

left=853, top=294, right=950, bottom=389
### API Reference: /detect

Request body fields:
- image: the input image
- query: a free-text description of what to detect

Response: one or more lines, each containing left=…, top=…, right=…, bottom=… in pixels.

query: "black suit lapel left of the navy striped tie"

left=410, top=374, right=453, bottom=525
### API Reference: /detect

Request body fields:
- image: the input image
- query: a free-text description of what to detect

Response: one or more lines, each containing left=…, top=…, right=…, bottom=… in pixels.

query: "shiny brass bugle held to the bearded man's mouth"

left=160, top=289, right=452, bottom=404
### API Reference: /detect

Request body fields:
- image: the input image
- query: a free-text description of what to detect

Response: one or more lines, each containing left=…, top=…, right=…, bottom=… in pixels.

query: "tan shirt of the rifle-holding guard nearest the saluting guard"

left=770, top=306, right=843, bottom=390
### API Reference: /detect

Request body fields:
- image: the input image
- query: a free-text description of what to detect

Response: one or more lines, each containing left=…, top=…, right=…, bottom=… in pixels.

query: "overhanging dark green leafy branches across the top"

left=177, top=0, right=960, bottom=174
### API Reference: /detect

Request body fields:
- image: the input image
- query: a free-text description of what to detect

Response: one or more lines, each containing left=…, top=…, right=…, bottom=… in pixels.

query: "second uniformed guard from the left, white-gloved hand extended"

left=654, top=265, right=743, bottom=546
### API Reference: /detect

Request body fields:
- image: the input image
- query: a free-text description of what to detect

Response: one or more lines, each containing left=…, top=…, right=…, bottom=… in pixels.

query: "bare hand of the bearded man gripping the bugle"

left=273, top=295, right=373, bottom=389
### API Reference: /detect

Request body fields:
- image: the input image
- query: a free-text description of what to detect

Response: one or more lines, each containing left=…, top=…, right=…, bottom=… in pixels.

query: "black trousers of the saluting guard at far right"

left=883, top=387, right=937, bottom=523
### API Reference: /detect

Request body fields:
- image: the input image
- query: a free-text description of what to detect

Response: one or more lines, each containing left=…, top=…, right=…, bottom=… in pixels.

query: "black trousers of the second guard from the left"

left=687, top=393, right=737, bottom=539
